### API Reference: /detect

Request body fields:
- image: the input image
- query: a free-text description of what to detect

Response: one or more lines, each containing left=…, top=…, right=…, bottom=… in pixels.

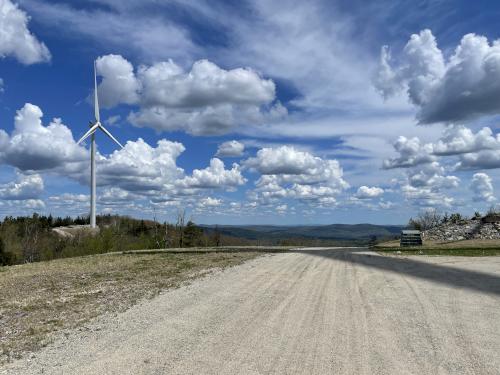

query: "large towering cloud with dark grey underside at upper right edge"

left=375, top=30, right=500, bottom=124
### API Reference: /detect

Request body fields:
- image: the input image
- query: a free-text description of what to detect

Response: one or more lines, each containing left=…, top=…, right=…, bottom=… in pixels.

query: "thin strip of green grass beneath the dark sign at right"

left=374, top=240, right=500, bottom=256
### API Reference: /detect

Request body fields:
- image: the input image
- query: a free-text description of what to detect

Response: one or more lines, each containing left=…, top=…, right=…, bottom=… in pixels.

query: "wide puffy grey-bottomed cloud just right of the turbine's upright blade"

left=97, top=55, right=280, bottom=135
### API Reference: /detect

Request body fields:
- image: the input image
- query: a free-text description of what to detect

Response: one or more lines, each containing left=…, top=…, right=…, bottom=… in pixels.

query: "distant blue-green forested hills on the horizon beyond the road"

left=201, top=224, right=403, bottom=242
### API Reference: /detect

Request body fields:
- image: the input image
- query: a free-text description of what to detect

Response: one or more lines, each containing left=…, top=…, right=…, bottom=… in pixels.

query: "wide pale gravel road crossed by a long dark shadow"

left=0, top=248, right=500, bottom=375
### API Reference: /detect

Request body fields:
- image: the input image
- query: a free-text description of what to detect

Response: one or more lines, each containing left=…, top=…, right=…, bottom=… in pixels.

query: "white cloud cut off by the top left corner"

left=0, top=0, right=51, bottom=65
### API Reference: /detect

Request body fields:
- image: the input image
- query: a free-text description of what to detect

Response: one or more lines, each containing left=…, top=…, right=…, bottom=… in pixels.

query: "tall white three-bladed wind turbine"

left=76, top=61, right=123, bottom=228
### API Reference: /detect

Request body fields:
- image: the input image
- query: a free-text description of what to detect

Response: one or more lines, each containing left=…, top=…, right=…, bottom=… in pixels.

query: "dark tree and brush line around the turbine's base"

left=0, top=213, right=222, bottom=266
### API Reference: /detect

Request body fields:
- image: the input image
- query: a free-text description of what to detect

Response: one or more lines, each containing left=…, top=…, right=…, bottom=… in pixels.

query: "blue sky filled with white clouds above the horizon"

left=0, top=0, right=500, bottom=225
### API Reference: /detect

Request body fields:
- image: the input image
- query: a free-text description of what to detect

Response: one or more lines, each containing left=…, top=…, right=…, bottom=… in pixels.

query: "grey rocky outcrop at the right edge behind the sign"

left=423, top=219, right=500, bottom=242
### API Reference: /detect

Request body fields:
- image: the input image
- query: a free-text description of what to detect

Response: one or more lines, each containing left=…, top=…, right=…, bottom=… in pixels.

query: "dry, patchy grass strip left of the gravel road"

left=0, top=251, right=266, bottom=364
